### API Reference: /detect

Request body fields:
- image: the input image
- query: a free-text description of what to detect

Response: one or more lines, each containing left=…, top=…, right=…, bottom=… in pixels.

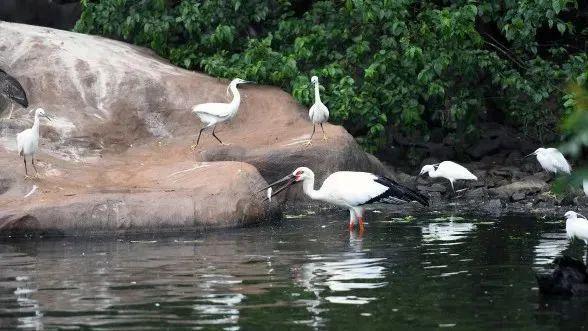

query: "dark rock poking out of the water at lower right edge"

left=537, top=255, right=588, bottom=296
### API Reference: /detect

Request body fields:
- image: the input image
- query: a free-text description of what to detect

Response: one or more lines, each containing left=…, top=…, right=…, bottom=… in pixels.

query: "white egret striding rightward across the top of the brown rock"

left=192, top=78, right=252, bottom=147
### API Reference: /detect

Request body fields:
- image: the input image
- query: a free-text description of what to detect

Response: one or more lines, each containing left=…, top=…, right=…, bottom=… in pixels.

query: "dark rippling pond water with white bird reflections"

left=0, top=211, right=588, bottom=330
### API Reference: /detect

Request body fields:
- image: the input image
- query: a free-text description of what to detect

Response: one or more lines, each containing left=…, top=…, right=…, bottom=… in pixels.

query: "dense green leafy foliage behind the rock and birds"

left=76, top=0, right=587, bottom=150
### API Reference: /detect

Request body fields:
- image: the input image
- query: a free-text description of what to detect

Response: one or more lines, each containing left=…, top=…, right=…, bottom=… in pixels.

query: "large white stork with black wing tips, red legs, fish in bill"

left=262, top=167, right=429, bottom=231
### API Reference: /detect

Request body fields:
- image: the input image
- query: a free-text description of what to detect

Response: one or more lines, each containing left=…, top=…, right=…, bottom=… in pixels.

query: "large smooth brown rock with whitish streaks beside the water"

left=0, top=22, right=389, bottom=235
